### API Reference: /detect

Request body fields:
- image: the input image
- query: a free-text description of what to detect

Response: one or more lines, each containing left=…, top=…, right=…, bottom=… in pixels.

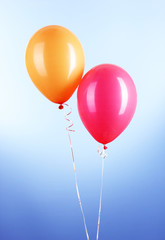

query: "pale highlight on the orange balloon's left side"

left=34, top=43, right=47, bottom=77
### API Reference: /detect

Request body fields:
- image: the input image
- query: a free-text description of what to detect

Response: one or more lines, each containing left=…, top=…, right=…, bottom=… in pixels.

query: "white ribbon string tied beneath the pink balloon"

left=96, top=146, right=108, bottom=240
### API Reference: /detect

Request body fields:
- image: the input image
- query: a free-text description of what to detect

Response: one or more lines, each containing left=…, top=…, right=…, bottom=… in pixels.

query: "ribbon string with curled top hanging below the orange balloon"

left=64, top=103, right=89, bottom=240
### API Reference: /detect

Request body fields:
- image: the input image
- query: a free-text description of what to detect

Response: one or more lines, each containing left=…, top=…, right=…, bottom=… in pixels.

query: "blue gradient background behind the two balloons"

left=0, top=0, right=165, bottom=240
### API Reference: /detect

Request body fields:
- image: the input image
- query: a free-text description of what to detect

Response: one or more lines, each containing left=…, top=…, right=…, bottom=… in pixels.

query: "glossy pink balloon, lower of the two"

left=77, top=64, right=137, bottom=144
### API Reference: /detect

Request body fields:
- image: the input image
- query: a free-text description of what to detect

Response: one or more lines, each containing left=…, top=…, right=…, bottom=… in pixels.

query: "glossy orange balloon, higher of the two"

left=25, top=25, right=84, bottom=104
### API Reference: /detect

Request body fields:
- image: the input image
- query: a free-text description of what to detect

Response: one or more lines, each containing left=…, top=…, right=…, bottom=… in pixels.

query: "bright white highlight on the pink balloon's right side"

left=117, top=77, right=128, bottom=115
